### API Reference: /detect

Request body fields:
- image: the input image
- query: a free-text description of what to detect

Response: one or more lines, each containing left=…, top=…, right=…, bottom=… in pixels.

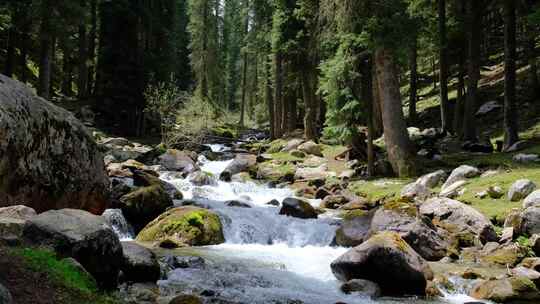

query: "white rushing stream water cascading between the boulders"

left=107, top=146, right=488, bottom=304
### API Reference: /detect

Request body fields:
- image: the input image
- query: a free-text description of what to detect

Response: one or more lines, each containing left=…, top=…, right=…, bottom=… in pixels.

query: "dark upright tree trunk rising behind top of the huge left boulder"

left=38, top=0, right=52, bottom=99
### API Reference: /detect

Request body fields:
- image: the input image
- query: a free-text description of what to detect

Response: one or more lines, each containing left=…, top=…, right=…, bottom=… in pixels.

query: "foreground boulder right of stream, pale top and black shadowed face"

left=331, top=232, right=433, bottom=295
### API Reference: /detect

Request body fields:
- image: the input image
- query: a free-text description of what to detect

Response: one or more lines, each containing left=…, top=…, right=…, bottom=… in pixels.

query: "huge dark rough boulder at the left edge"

left=0, top=75, right=109, bottom=214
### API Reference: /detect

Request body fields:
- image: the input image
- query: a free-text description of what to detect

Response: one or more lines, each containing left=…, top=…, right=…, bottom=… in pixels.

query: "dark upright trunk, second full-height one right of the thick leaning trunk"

left=463, top=1, right=482, bottom=142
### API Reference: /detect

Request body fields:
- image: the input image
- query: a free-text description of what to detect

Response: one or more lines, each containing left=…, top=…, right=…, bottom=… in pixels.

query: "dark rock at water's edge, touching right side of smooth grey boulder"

left=122, top=242, right=160, bottom=282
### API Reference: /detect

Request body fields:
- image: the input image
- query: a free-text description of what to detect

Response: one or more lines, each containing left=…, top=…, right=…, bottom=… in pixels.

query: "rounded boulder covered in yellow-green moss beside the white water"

left=137, top=206, right=225, bottom=246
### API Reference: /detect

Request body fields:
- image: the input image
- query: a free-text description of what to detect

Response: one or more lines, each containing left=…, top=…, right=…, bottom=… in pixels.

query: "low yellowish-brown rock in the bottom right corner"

left=471, top=277, right=540, bottom=303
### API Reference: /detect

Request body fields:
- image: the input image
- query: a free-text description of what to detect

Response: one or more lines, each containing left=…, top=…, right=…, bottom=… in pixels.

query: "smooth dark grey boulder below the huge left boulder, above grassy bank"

left=23, top=209, right=123, bottom=289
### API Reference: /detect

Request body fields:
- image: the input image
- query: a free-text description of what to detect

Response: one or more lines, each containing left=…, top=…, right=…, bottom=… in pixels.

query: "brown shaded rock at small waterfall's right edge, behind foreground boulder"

left=335, top=210, right=374, bottom=247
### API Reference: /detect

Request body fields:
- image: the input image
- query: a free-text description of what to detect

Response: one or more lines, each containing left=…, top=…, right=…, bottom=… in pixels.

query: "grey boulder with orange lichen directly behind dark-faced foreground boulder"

left=370, top=202, right=449, bottom=261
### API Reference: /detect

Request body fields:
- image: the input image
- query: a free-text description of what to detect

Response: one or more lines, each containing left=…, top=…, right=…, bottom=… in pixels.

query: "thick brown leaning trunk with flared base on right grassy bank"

left=375, top=47, right=416, bottom=177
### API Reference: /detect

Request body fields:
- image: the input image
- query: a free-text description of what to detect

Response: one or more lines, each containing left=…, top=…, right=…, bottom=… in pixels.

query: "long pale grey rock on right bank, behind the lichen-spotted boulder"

left=420, top=198, right=498, bottom=243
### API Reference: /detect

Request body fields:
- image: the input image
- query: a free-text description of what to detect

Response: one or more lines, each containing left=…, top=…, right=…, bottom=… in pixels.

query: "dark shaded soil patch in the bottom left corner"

left=0, top=247, right=58, bottom=304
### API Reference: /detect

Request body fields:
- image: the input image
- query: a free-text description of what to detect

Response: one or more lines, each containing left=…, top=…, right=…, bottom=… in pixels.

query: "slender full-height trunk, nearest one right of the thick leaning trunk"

left=439, top=0, right=452, bottom=133
